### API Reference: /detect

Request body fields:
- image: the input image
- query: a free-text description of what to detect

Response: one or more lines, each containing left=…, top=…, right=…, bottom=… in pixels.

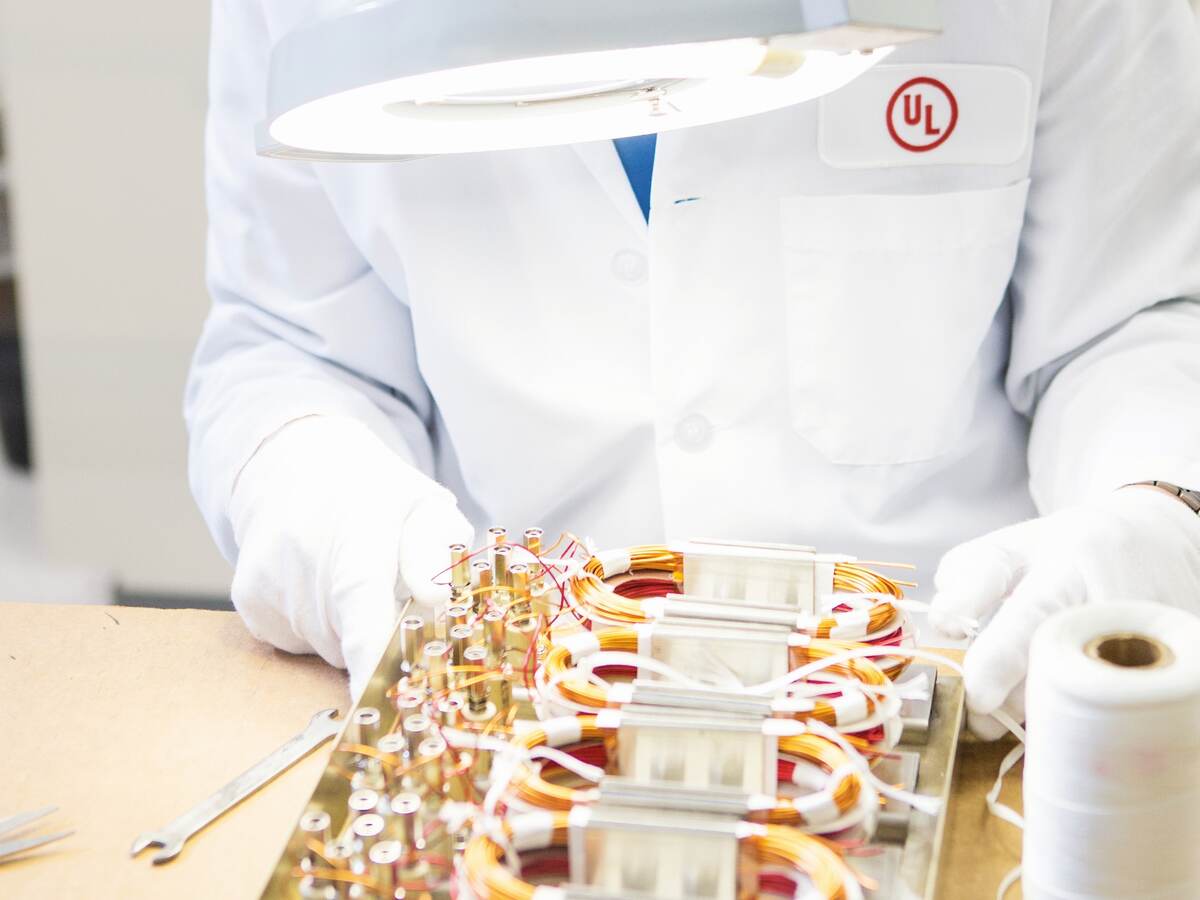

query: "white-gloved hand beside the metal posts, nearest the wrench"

left=229, top=416, right=473, bottom=698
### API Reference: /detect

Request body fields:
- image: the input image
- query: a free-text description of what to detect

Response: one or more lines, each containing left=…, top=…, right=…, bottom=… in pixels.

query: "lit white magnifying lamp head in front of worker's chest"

left=259, top=0, right=938, bottom=160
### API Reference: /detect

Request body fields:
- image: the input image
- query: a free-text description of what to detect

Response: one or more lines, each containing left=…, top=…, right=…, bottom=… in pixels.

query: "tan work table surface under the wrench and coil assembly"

left=0, top=604, right=1020, bottom=900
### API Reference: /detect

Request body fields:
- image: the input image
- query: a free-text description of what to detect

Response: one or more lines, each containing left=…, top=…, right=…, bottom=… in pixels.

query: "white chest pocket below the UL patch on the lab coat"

left=782, top=180, right=1028, bottom=466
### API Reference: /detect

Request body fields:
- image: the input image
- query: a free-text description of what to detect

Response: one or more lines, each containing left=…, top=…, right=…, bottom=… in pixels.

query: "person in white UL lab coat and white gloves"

left=186, top=0, right=1200, bottom=731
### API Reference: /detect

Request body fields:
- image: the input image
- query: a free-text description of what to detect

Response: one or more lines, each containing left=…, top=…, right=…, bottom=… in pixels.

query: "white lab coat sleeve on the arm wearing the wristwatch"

left=1008, top=0, right=1200, bottom=514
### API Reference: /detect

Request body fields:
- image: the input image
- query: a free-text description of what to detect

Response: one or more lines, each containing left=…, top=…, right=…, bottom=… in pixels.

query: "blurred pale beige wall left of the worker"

left=0, top=0, right=229, bottom=600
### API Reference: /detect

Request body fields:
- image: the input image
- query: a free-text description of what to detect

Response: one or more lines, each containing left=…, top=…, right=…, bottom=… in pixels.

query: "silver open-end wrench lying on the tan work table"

left=130, top=709, right=342, bottom=864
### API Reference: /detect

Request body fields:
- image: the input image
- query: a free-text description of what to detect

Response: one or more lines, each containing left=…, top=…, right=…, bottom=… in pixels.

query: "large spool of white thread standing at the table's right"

left=1021, top=604, right=1200, bottom=900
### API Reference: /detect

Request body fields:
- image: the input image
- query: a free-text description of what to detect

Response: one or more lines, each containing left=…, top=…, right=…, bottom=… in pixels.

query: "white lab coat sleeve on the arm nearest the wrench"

left=185, top=0, right=434, bottom=562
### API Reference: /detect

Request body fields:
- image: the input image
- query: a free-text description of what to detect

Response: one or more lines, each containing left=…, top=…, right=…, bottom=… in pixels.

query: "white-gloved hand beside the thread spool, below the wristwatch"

left=929, top=486, right=1200, bottom=740
